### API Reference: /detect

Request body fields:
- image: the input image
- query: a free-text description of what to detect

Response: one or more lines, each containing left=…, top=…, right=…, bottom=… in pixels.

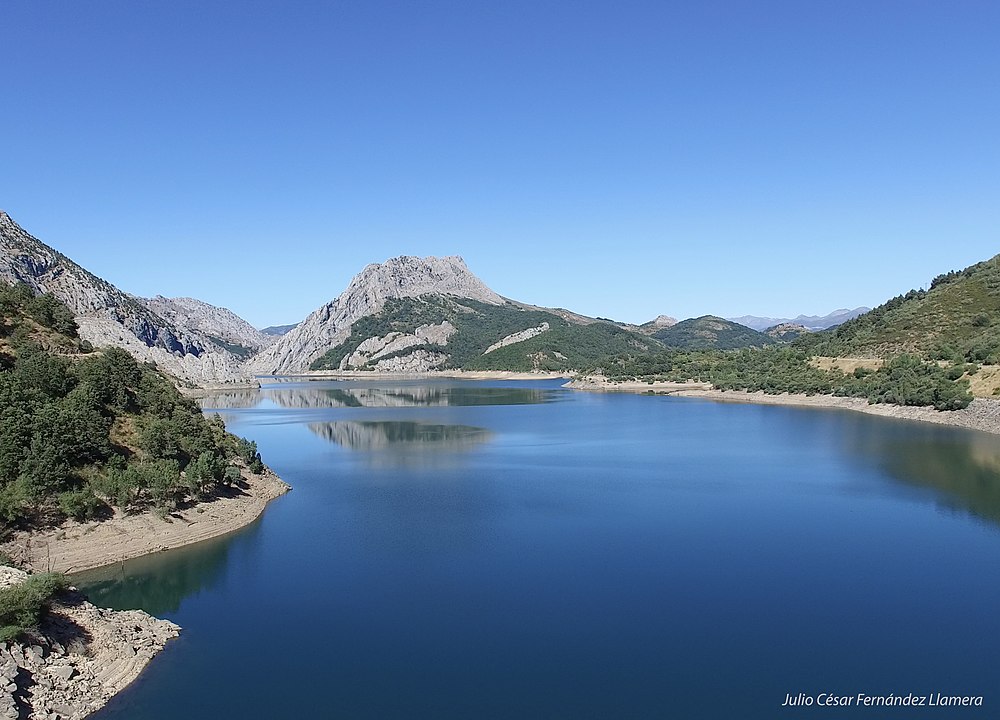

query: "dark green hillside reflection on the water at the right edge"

left=845, top=423, right=1000, bottom=525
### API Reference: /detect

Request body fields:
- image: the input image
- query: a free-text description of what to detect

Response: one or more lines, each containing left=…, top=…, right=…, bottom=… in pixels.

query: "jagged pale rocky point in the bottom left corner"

left=0, top=567, right=180, bottom=720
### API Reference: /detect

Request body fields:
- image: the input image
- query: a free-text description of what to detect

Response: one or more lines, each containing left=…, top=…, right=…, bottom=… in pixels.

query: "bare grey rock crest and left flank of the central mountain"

left=248, top=256, right=504, bottom=375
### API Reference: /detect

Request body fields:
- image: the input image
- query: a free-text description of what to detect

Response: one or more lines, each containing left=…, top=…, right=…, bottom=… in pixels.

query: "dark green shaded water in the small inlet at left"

left=72, top=523, right=260, bottom=617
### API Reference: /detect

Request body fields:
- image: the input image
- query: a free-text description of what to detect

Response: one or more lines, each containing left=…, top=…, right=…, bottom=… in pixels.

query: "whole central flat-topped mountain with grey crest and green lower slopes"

left=249, top=257, right=659, bottom=374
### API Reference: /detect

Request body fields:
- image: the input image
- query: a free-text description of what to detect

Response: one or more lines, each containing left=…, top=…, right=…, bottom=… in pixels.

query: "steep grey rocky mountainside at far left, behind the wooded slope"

left=0, top=211, right=244, bottom=382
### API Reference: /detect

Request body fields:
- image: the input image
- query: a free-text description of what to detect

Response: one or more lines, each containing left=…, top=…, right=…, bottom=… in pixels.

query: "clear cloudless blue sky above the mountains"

left=0, top=0, right=1000, bottom=326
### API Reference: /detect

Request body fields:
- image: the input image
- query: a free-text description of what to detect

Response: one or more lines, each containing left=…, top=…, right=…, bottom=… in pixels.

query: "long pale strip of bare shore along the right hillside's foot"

left=566, top=378, right=1000, bottom=435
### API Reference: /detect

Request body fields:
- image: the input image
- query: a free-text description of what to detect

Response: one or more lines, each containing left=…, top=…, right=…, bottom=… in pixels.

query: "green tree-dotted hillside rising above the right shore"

left=587, top=255, right=1000, bottom=410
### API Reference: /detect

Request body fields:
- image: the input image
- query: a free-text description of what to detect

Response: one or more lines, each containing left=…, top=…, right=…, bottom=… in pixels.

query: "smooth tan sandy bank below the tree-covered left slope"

left=0, top=468, right=290, bottom=573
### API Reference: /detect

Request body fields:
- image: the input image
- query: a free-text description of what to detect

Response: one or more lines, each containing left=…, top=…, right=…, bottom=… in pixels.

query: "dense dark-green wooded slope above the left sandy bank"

left=0, top=284, right=263, bottom=530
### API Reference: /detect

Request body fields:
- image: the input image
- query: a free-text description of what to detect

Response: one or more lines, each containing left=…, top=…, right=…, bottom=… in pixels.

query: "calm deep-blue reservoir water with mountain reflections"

left=81, top=381, right=1000, bottom=720
